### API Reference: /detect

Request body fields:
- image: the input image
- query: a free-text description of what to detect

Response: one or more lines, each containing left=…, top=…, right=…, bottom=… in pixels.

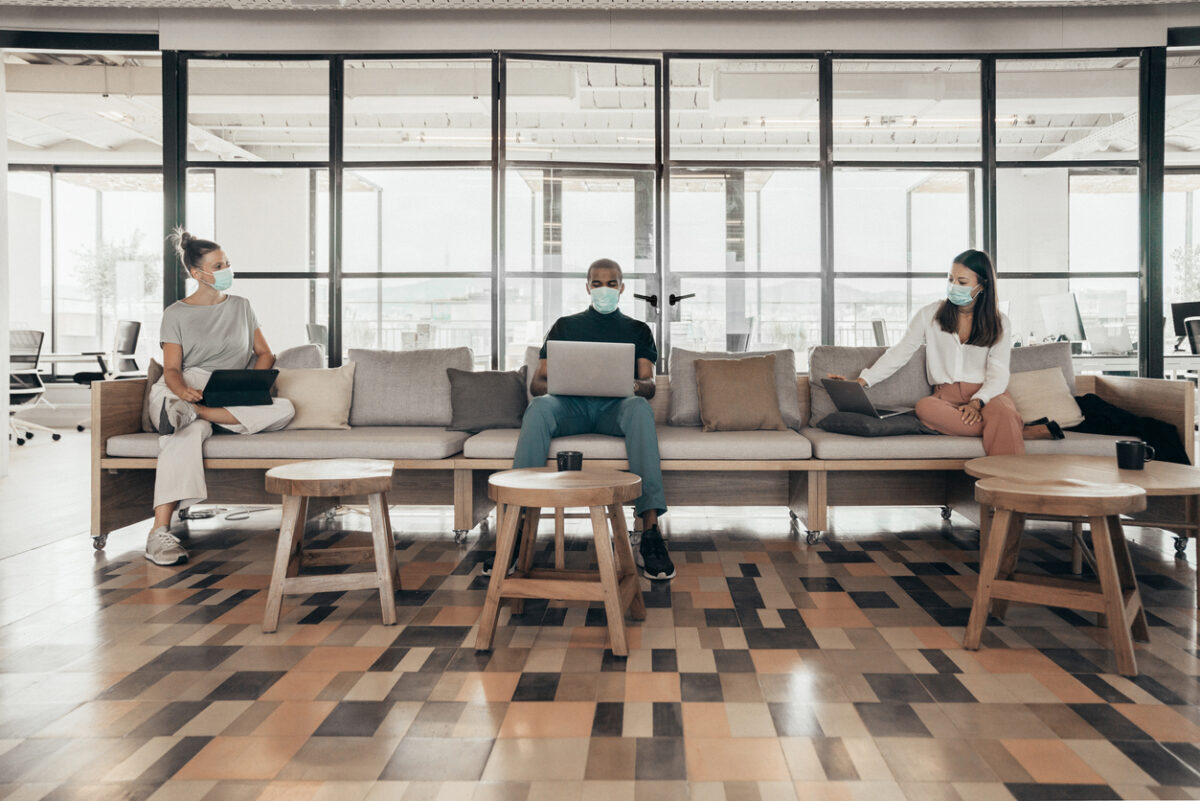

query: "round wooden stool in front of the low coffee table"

left=962, top=478, right=1150, bottom=676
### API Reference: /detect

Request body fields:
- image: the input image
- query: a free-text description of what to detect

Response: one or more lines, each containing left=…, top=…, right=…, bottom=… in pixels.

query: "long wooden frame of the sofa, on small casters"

left=91, top=375, right=1198, bottom=549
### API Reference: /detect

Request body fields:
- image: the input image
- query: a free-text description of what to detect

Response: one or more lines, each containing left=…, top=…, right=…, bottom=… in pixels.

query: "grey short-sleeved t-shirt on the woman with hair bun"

left=158, top=295, right=258, bottom=371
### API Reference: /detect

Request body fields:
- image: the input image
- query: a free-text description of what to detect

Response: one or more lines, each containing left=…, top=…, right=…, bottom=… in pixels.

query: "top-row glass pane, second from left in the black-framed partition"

left=344, top=59, right=492, bottom=161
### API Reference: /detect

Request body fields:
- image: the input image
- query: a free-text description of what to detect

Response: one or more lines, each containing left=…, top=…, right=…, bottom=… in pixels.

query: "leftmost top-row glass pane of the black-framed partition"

left=187, top=59, right=329, bottom=162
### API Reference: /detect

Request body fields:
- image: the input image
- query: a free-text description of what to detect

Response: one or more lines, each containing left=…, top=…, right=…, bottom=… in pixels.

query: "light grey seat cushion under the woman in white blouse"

left=803, top=428, right=1121, bottom=460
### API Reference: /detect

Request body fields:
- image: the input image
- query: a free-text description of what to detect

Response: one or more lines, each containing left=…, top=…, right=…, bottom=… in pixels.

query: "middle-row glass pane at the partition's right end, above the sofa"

left=996, top=168, right=1140, bottom=272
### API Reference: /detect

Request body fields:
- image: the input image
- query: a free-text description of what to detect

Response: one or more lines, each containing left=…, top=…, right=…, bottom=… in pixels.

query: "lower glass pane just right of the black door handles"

left=671, top=278, right=821, bottom=369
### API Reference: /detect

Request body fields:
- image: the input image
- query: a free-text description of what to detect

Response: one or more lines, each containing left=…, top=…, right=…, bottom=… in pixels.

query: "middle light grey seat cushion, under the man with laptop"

left=462, top=426, right=812, bottom=466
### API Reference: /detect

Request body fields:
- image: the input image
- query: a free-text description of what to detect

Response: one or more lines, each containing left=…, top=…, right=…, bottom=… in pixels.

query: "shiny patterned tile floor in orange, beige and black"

left=0, top=508, right=1200, bottom=801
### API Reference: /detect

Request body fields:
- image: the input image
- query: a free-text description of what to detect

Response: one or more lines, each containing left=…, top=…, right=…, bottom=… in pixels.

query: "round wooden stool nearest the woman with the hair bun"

left=263, top=459, right=400, bottom=632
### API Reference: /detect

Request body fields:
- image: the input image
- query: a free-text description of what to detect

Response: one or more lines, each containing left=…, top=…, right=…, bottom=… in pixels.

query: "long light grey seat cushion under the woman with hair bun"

left=107, top=426, right=470, bottom=459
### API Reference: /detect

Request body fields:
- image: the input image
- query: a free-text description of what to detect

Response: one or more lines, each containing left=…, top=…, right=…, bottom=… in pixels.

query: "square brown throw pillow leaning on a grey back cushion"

left=695, top=354, right=787, bottom=432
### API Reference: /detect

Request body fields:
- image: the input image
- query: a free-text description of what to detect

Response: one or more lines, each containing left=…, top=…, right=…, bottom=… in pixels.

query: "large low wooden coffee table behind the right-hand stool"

left=964, top=453, right=1200, bottom=606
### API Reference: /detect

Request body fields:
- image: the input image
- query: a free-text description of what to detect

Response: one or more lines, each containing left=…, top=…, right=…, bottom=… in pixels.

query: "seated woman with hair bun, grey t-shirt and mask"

left=145, top=228, right=295, bottom=565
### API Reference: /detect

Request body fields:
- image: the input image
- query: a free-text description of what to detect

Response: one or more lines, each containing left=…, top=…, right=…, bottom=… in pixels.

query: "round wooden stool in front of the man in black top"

left=475, top=468, right=646, bottom=656
